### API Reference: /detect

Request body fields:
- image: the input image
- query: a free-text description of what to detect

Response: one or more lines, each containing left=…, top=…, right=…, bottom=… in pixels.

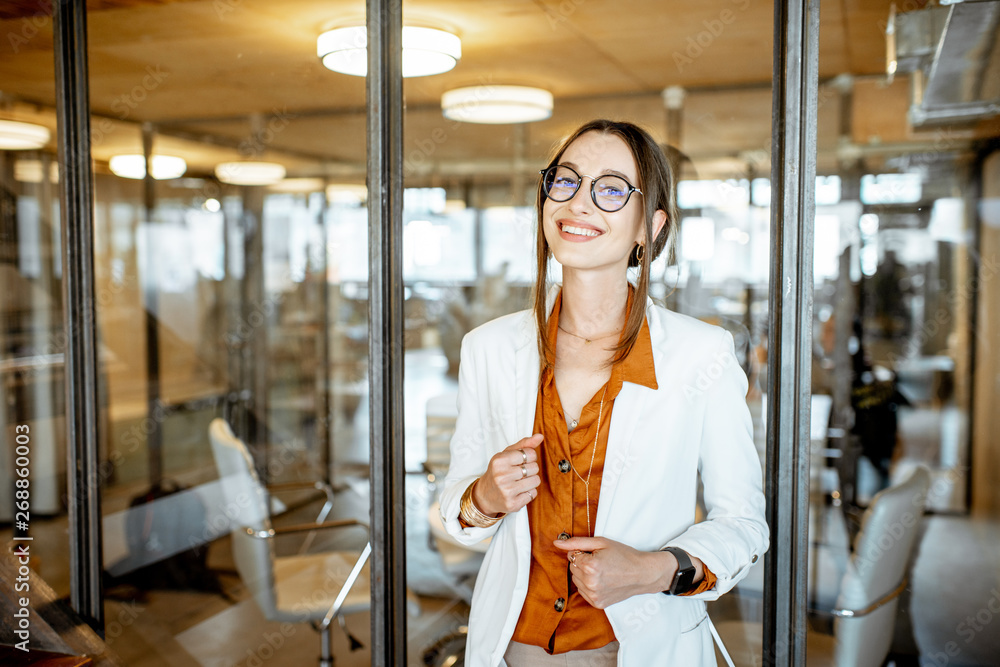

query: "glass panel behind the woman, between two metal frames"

left=404, top=1, right=773, bottom=665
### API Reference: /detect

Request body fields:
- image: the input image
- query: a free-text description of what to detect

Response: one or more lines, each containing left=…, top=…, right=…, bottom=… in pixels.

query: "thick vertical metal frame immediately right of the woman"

left=763, top=0, right=819, bottom=667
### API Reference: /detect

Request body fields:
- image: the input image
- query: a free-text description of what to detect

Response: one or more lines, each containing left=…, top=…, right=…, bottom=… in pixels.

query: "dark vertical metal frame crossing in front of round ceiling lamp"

left=367, top=0, right=407, bottom=667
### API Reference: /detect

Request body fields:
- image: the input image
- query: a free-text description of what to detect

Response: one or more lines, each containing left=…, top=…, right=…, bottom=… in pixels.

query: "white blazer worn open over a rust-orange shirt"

left=441, top=301, right=768, bottom=667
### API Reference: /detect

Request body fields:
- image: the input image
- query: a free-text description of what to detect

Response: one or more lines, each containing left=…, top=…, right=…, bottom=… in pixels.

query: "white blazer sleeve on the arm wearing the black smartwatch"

left=666, top=330, right=769, bottom=600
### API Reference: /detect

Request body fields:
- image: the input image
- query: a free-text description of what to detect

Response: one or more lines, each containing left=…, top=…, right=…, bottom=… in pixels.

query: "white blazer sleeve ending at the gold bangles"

left=441, top=334, right=503, bottom=544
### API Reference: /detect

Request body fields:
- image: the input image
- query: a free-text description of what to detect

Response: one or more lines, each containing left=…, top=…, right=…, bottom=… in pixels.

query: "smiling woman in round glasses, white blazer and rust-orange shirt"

left=441, top=120, right=768, bottom=667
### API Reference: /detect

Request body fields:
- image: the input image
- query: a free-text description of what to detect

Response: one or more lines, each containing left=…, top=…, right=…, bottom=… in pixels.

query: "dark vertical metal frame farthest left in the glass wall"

left=52, top=0, right=104, bottom=634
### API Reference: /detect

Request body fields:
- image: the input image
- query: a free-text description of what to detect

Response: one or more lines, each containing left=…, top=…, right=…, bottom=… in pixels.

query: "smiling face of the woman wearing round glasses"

left=542, top=132, right=645, bottom=275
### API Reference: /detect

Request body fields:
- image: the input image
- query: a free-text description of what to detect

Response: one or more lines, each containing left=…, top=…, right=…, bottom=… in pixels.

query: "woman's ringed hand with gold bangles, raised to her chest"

left=472, top=433, right=542, bottom=516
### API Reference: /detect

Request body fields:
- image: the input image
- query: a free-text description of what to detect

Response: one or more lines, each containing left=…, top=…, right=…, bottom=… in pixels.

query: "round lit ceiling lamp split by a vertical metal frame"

left=316, top=25, right=462, bottom=78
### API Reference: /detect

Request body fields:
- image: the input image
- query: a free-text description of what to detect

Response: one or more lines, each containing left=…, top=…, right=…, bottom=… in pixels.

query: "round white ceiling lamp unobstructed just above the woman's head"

left=441, top=86, right=552, bottom=125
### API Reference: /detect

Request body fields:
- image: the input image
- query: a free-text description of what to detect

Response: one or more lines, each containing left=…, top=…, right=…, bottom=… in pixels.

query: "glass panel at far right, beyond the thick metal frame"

left=808, top=3, right=1000, bottom=665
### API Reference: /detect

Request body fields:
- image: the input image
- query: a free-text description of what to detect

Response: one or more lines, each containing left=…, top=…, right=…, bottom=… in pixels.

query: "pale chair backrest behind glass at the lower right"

left=834, top=467, right=930, bottom=667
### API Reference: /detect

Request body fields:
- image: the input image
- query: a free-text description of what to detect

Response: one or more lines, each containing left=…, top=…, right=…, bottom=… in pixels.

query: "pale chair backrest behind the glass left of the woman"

left=208, top=419, right=277, bottom=618
